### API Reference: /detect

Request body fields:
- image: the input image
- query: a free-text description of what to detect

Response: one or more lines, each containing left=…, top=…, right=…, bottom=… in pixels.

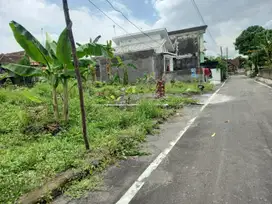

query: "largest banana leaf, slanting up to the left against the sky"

left=9, top=21, right=52, bottom=64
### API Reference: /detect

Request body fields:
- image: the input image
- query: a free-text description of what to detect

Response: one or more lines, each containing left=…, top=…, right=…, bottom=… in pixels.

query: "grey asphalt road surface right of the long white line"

left=130, top=76, right=272, bottom=204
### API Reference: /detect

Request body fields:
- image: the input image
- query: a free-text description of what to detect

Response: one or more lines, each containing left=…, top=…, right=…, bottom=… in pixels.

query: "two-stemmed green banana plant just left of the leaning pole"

left=4, top=21, right=73, bottom=121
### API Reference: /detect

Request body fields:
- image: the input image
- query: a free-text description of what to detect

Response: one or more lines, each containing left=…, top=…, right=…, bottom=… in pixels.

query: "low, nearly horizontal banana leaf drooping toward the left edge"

left=2, top=64, right=43, bottom=77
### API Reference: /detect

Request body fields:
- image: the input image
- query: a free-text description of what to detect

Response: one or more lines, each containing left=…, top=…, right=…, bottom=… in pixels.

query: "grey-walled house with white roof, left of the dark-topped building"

left=99, top=28, right=175, bottom=82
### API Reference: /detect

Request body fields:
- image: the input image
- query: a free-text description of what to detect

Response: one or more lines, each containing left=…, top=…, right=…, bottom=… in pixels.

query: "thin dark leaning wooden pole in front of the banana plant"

left=62, top=0, right=90, bottom=150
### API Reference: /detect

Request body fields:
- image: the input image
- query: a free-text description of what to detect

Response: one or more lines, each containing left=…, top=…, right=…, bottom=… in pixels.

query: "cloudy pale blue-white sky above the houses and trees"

left=0, top=0, right=272, bottom=56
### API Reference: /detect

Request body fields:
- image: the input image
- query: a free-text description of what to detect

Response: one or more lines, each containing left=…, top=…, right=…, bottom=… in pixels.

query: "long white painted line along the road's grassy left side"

left=116, top=81, right=226, bottom=204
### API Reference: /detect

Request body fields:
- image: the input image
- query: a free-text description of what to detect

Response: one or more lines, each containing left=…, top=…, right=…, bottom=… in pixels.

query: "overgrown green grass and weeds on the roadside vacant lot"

left=0, top=80, right=212, bottom=203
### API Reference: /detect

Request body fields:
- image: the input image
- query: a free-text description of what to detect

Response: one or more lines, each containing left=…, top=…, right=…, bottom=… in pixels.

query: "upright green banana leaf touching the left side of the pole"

left=57, top=28, right=72, bottom=65
